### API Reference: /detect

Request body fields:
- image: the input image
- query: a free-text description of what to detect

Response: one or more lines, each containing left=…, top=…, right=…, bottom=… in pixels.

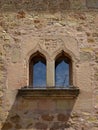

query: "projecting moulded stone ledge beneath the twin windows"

left=18, top=87, right=79, bottom=99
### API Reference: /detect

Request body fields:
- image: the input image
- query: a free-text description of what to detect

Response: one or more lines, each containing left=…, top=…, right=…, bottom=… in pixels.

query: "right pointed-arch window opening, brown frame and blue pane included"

left=55, top=52, right=72, bottom=87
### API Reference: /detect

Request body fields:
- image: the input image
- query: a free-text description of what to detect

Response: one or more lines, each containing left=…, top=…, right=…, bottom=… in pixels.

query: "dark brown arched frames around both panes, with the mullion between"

left=29, top=50, right=73, bottom=88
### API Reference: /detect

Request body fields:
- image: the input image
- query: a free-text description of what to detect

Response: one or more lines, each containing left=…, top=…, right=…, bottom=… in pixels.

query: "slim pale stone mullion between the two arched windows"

left=47, top=61, right=55, bottom=87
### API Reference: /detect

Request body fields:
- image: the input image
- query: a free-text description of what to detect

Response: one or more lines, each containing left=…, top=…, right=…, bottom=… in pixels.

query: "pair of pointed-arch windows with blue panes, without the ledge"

left=29, top=51, right=72, bottom=88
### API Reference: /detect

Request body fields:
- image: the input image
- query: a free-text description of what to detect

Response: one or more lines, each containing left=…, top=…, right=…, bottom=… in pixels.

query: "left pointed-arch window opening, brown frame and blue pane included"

left=29, top=52, right=46, bottom=88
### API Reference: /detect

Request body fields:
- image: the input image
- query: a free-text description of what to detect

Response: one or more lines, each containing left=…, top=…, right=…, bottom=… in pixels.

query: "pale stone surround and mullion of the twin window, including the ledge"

left=19, top=46, right=80, bottom=99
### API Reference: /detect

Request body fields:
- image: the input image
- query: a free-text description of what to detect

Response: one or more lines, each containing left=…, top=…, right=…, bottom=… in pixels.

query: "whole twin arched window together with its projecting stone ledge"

left=19, top=51, right=79, bottom=99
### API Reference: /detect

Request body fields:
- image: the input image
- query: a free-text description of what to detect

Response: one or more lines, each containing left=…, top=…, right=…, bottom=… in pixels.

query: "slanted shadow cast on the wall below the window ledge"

left=1, top=94, right=75, bottom=130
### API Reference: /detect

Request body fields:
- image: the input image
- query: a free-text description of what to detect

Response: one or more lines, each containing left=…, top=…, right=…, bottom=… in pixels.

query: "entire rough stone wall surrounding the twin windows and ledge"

left=0, top=0, right=98, bottom=130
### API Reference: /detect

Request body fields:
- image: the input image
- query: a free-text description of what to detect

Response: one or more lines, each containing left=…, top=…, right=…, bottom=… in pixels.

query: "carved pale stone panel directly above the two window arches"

left=27, top=35, right=79, bottom=61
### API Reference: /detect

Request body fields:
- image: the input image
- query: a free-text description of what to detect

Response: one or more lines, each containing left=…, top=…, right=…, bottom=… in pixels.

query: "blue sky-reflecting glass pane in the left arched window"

left=33, top=61, right=46, bottom=87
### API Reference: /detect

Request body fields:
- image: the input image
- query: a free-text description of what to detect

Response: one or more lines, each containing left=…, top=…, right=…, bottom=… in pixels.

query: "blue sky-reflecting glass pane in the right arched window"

left=55, top=60, right=69, bottom=87
